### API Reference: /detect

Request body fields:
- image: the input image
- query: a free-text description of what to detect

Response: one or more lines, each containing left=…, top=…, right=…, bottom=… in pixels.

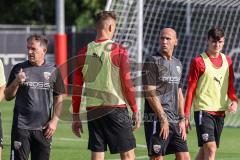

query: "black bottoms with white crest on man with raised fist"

left=10, top=128, right=51, bottom=160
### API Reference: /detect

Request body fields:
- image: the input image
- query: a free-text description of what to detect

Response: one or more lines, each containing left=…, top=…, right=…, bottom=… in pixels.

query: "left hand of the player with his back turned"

left=72, top=114, right=83, bottom=137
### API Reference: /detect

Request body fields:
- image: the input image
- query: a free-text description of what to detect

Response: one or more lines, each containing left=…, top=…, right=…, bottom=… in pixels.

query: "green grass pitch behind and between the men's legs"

left=0, top=101, right=240, bottom=160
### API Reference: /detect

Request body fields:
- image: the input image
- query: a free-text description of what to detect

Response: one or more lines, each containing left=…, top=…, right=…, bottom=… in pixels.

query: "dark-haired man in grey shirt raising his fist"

left=5, top=35, right=64, bottom=160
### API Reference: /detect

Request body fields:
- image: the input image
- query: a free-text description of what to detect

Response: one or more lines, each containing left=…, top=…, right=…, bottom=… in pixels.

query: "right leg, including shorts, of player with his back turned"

left=103, top=108, right=136, bottom=156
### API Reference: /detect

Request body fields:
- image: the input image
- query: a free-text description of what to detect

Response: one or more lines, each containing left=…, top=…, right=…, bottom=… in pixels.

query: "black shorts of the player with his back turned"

left=87, top=108, right=136, bottom=154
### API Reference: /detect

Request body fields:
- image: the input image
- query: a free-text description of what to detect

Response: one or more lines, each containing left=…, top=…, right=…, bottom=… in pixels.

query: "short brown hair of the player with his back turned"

left=96, top=11, right=117, bottom=27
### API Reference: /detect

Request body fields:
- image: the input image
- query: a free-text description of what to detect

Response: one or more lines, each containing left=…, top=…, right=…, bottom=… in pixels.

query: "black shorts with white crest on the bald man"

left=144, top=120, right=188, bottom=156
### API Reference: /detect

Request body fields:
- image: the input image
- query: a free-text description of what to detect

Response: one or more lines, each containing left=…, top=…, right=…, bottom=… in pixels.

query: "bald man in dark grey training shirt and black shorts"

left=143, top=28, right=190, bottom=160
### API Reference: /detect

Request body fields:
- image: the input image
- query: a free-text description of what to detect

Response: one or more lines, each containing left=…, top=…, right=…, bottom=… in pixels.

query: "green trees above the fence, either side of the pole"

left=0, top=0, right=106, bottom=29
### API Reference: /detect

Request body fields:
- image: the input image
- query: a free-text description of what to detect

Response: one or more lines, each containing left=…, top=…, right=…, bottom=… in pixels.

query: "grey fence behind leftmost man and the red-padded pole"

left=0, top=25, right=95, bottom=83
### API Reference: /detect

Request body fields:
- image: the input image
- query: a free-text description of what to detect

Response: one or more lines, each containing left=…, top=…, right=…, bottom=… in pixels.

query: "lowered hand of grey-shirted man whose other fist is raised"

left=43, top=118, right=58, bottom=139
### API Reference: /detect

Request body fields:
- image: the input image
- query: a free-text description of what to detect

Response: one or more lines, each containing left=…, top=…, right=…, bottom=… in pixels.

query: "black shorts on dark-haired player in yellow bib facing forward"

left=194, top=111, right=225, bottom=147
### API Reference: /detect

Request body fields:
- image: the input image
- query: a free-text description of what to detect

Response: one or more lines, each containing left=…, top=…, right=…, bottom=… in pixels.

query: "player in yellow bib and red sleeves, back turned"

left=72, top=11, right=140, bottom=160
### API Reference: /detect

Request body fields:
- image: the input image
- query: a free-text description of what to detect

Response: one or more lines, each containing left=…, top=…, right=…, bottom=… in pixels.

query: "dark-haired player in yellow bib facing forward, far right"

left=185, top=28, right=237, bottom=160
